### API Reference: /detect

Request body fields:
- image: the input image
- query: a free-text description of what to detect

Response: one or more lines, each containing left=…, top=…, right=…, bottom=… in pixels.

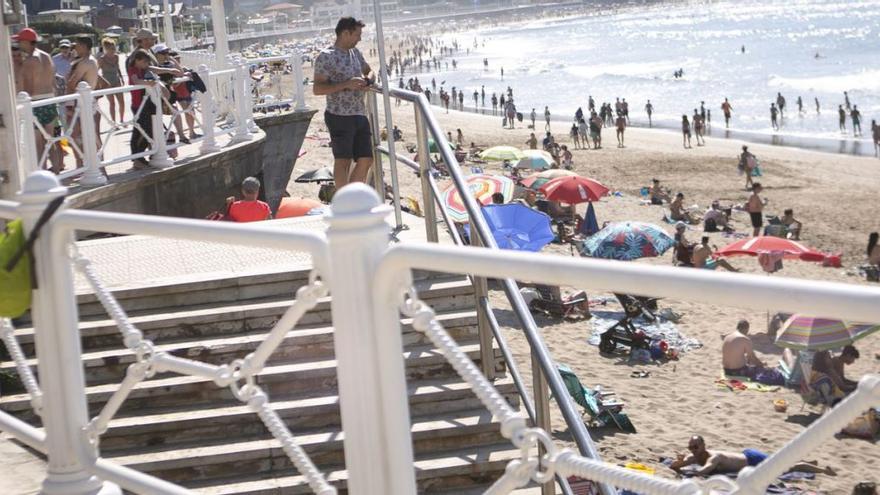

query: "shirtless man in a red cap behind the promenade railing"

left=12, top=28, right=64, bottom=174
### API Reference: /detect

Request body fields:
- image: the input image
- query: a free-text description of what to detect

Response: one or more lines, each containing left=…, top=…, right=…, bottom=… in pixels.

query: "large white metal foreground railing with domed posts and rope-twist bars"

left=0, top=171, right=880, bottom=495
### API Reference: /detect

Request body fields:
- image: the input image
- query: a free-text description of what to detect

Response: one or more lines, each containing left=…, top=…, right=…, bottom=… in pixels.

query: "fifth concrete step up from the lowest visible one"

left=0, top=310, right=477, bottom=385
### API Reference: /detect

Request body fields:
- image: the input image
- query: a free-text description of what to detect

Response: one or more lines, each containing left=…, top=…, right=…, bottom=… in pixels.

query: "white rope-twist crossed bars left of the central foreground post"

left=71, top=250, right=336, bottom=495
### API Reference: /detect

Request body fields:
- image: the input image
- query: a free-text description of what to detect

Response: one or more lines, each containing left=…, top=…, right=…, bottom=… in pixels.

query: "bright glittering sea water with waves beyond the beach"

left=422, top=0, right=880, bottom=153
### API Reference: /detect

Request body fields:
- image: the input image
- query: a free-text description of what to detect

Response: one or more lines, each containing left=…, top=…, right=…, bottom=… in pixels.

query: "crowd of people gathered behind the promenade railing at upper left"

left=12, top=28, right=204, bottom=174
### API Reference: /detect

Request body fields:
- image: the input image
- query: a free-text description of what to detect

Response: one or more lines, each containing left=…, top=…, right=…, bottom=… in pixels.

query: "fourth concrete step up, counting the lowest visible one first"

left=0, top=343, right=504, bottom=421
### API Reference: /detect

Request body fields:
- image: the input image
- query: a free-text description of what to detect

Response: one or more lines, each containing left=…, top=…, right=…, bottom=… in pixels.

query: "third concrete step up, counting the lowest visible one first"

left=101, top=377, right=519, bottom=453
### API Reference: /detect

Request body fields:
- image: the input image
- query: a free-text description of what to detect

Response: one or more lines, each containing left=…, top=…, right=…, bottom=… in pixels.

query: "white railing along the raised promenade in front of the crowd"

left=17, top=52, right=307, bottom=187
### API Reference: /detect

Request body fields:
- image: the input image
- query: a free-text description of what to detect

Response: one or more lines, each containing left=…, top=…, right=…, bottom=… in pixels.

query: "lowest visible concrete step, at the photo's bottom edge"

left=192, top=442, right=520, bottom=495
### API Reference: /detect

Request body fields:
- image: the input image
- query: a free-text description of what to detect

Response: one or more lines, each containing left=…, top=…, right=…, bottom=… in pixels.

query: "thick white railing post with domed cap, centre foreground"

left=322, top=183, right=416, bottom=495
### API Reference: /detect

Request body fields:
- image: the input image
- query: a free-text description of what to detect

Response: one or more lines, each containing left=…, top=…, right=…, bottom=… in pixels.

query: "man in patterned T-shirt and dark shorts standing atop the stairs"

left=313, top=17, right=373, bottom=191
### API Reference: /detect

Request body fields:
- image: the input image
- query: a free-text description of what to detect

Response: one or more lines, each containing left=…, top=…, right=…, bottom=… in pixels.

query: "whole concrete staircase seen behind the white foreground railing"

left=0, top=270, right=519, bottom=495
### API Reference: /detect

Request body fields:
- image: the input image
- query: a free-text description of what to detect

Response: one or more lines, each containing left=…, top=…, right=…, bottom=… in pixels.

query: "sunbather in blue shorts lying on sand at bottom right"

left=669, top=435, right=837, bottom=476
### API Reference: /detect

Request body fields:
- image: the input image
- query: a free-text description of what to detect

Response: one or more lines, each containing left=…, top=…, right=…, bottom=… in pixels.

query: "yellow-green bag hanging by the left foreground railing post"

left=0, top=220, right=31, bottom=318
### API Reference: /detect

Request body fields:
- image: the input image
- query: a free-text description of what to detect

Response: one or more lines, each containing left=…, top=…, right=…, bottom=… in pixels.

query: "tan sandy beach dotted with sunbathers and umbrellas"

left=288, top=86, right=880, bottom=493
